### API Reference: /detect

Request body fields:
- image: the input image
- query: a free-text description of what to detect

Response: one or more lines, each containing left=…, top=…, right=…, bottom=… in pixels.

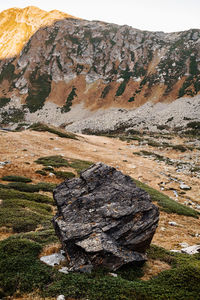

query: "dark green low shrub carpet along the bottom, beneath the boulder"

left=0, top=237, right=200, bottom=300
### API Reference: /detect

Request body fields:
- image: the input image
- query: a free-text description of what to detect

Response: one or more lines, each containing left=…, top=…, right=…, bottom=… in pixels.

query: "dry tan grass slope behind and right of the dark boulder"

left=0, top=130, right=200, bottom=249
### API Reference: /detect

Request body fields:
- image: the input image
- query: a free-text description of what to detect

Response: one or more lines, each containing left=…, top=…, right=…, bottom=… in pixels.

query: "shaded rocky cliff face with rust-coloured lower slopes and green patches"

left=0, top=7, right=200, bottom=129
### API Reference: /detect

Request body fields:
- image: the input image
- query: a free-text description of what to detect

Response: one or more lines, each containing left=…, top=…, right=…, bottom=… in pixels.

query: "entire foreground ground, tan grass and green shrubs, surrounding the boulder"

left=0, top=125, right=200, bottom=300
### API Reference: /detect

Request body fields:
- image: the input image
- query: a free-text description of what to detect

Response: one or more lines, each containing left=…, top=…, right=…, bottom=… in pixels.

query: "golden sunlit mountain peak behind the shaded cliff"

left=0, top=6, right=75, bottom=59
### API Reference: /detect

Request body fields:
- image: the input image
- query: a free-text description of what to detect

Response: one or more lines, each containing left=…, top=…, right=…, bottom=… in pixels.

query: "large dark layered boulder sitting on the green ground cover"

left=53, top=163, right=159, bottom=271
